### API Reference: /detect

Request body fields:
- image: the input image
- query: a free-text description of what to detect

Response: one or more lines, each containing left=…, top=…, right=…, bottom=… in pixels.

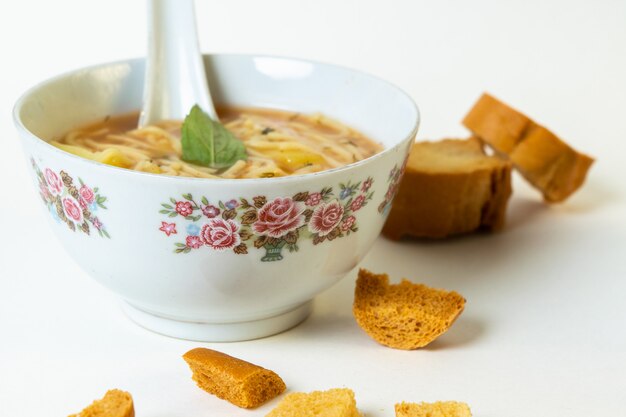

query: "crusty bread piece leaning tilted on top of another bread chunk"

left=463, top=94, right=593, bottom=203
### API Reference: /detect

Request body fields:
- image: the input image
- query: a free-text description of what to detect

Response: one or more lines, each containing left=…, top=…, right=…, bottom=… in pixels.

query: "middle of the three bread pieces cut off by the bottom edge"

left=266, top=388, right=360, bottom=417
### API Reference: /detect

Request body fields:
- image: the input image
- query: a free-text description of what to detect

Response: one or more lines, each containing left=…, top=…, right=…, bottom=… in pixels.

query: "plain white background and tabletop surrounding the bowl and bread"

left=0, top=0, right=626, bottom=417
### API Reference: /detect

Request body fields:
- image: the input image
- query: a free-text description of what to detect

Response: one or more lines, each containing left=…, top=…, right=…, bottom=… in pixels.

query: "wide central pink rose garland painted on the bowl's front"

left=159, top=177, right=374, bottom=262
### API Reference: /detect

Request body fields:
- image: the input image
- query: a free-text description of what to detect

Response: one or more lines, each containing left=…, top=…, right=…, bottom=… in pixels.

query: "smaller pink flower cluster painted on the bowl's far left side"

left=30, top=158, right=111, bottom=239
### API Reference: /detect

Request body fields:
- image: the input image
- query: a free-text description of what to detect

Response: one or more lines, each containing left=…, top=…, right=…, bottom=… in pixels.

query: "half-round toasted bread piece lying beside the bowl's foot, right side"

left=352, top=269, right=465, bottom=350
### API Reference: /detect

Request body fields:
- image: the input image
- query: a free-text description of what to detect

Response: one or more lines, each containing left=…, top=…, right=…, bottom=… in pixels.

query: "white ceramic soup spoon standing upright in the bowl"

left=139, top=0, right=218, bottom=127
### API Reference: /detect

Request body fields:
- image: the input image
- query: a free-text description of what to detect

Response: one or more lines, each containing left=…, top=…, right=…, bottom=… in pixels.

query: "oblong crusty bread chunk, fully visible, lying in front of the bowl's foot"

left=183, top=348, right=286, bottom=408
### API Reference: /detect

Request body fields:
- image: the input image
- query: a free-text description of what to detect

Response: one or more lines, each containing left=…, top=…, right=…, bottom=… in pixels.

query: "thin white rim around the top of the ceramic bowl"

left=12, top=53, right=421, bottom=184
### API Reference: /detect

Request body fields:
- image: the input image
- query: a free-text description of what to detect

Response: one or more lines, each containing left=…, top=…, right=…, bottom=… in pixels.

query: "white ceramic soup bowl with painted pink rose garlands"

left=14, top=55, right=419, bottom=341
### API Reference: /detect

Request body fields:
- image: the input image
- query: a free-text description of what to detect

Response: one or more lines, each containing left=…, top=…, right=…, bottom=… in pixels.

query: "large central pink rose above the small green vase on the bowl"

left=252, top=197, right=305, bottom=238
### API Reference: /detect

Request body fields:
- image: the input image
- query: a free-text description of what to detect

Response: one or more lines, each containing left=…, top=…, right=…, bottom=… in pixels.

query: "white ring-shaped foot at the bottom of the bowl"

left=122, top=301, right=312, bottom=342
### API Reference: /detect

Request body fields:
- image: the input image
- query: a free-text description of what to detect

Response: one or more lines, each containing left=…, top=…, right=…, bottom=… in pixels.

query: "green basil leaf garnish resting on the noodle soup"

left=181, top=105, right=248, bottom=169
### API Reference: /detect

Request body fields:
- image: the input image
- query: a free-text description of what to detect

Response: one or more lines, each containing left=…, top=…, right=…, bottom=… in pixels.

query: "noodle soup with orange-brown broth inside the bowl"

left=51, top=107, right=383, bottom=178
